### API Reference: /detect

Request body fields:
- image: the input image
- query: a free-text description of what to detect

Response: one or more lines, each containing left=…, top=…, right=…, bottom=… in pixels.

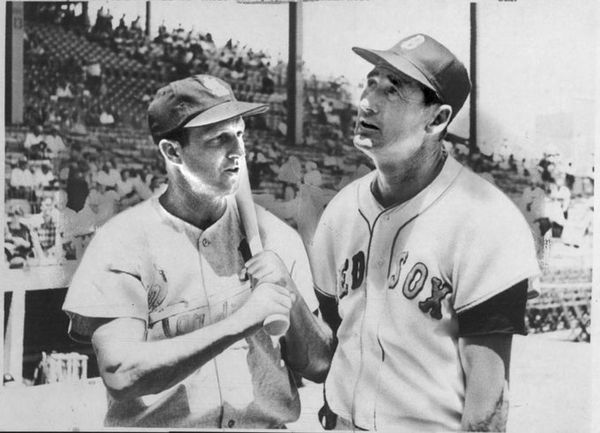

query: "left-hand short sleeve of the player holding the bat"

left=63, top=223, right=148, bottom=340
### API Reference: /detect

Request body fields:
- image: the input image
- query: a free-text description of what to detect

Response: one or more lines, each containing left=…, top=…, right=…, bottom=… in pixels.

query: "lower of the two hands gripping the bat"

left=234, top=283, right=296, bottom=330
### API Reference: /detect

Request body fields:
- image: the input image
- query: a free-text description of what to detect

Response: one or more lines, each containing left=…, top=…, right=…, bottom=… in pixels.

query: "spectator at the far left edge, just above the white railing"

left=4, top=207, right=33, bottom=269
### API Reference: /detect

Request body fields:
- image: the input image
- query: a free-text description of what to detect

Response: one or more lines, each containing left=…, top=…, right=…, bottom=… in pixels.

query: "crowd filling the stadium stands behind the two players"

left=5, top=3, right=593, bottom=339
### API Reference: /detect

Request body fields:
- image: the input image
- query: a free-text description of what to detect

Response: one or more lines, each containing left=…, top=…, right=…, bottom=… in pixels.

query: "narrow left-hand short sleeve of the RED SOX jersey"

left=308, top=203, right=336, bottom=298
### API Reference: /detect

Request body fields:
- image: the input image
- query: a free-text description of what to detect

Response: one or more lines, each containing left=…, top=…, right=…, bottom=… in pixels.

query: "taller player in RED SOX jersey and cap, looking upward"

left=309, top=34, right=538, bottom=432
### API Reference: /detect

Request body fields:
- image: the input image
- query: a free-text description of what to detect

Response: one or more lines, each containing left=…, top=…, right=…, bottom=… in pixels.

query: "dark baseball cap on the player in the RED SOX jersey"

left=352, top=33, right=471, bottom=118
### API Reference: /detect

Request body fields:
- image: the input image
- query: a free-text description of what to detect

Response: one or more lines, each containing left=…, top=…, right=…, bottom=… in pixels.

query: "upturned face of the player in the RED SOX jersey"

left=354, top=66, right=430, bottom=159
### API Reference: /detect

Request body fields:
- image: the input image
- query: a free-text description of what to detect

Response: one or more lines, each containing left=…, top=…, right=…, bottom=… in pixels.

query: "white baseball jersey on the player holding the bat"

left=63, top=197, right=318, bottom=428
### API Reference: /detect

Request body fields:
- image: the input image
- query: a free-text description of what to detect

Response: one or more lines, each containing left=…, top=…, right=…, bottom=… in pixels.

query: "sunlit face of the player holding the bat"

left=181, top=117, right=245, bottom=196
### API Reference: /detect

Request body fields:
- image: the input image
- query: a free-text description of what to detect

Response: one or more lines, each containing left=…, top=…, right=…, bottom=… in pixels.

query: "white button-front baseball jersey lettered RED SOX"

left=311, top=157, right=538, bottom=432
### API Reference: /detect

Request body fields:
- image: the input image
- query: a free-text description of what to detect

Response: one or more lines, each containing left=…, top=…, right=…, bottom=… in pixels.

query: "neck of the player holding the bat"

left=159, top=182, right=227, bottom=230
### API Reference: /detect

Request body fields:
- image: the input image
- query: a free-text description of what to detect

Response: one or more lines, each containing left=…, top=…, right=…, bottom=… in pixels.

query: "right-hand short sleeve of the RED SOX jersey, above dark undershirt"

left=452, top=203, right=539, bottom=313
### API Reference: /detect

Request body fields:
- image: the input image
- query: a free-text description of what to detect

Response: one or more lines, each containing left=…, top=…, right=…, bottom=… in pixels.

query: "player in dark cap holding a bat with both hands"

left=63, top=75, right=332, bottom=429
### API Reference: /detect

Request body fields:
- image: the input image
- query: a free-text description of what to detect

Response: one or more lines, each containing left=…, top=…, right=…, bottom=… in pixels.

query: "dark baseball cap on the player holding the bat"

left=148, top=75, right=269, bottom=142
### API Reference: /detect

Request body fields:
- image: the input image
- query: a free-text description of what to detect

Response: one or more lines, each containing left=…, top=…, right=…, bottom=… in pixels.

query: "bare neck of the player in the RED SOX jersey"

left=371, top=141, right=446, bottom=207
